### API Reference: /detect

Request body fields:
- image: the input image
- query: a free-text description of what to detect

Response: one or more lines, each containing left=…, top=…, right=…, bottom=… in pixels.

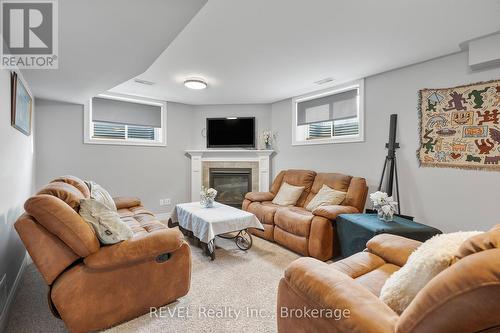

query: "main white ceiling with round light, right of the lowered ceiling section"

left=111, top=0, right=500, bottom=104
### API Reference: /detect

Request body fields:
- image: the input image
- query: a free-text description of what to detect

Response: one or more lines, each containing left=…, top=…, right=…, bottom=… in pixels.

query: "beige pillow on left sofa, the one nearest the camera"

left=80, top=199, right=134, bottom=244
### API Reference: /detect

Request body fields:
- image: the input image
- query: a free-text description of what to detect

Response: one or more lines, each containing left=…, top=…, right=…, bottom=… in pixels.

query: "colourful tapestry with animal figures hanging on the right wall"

left=417, top=80, right=500, bottom=171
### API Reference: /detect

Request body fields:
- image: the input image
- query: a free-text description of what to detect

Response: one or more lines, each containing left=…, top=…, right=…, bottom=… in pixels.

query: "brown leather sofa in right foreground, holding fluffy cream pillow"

left=278, top=225, right=500, bottom=333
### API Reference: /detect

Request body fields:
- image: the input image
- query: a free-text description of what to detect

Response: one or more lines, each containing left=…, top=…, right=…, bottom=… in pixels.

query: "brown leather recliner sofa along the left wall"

left=15, top=176, right=191, bottom=332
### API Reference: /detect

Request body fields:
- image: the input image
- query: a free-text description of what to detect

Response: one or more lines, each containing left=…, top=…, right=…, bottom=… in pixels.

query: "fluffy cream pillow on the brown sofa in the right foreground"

left=380, top=231, right=481, bottom=314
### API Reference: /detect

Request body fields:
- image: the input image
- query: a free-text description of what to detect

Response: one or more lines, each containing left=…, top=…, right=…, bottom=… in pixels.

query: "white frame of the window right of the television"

left=292, top=79, right=365, bottom=146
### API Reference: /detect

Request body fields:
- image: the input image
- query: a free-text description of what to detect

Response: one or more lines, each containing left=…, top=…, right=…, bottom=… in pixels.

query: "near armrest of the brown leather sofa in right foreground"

left=284, top=258, right=399, bottom=333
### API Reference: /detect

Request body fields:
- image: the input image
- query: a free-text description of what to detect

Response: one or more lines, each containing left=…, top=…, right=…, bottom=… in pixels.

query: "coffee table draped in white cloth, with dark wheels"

left=168, top=202, right=264, bottom=260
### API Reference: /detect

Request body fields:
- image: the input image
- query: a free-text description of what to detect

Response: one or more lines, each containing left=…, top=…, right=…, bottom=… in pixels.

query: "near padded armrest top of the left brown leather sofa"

left=84, top=229, right=184, bottom=269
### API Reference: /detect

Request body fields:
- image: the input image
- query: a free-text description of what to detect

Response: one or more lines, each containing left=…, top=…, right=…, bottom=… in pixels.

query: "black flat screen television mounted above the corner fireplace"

left=207, top=117, right=255, bottom=148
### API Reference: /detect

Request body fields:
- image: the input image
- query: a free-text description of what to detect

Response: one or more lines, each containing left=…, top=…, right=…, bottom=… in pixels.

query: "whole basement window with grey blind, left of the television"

left=85, top=94, right=166, bottom=146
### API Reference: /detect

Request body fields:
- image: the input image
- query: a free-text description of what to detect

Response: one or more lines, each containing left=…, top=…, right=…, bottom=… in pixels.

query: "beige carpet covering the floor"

left=7, top=232, right=298, bottom=333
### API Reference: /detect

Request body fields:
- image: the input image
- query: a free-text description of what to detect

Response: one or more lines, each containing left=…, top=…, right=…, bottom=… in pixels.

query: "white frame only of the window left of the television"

left=83, top=93, right=167, bottom=147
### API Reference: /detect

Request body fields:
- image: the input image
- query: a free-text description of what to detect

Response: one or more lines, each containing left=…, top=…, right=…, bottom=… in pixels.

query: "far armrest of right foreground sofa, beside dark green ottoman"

left=366, top=234, right=422, bottom=266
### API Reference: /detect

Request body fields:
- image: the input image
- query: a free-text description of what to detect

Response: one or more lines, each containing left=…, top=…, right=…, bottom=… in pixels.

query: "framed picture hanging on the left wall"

left=11, top=72, right=33, bottom=136
